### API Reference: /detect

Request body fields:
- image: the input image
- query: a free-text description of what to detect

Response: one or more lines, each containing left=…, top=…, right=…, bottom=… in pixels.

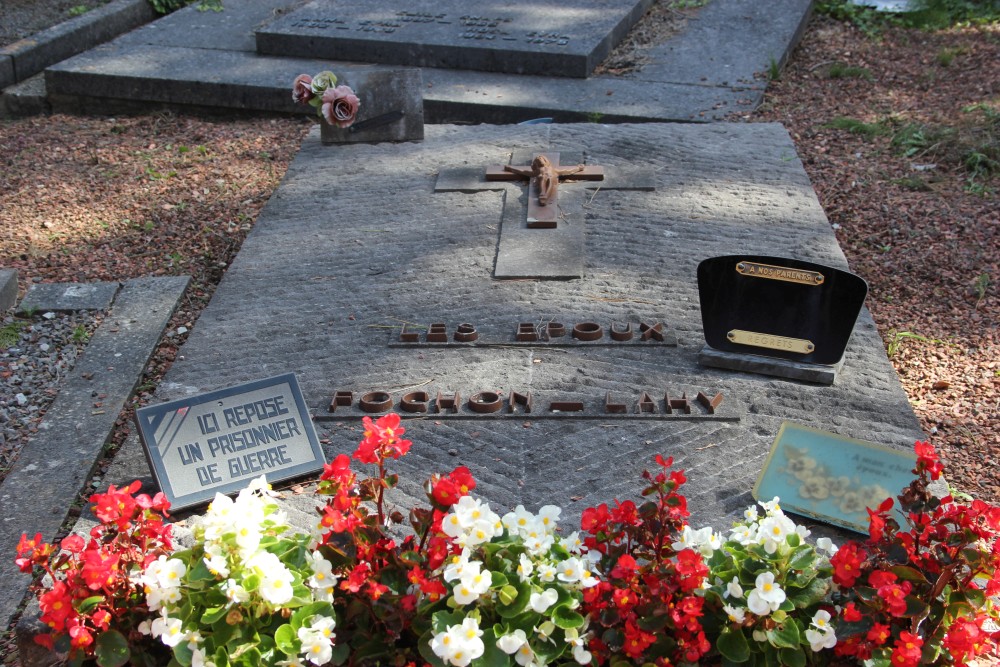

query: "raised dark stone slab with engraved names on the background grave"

left=256, top=0, right=652, bottom=79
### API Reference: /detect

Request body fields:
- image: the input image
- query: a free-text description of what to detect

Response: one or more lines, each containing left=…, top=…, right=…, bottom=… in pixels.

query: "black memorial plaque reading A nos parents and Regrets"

left=698, top=255, right=868, bottom=365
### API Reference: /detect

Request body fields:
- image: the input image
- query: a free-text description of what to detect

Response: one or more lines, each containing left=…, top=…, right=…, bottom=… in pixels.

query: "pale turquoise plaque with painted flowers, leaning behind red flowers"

left=753, top=421, right=916, bottom=533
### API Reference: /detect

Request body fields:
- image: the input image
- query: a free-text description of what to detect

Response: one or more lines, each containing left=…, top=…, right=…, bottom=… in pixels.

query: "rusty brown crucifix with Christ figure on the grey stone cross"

left=486, top=153, right=604, bottom=229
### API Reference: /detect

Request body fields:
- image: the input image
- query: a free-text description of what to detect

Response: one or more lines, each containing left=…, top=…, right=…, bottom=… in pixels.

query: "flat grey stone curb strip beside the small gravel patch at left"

left=0, top=276, right=190, bottom=627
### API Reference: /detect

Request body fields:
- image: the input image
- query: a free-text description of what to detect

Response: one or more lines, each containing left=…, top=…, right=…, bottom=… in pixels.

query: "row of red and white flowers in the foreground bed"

left=17, top=414, right=1000, bottom=667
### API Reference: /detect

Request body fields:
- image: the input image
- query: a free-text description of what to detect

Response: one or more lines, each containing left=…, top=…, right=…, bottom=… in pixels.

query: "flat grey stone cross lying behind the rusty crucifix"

left=434, top=151, right=656, bottom=279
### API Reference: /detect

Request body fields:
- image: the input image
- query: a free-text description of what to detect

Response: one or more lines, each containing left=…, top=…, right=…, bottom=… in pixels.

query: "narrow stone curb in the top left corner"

left=0, top=0, right=156, bottom=88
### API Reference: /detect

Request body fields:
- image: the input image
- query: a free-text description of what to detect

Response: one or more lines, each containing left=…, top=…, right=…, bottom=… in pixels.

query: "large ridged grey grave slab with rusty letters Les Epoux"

left=92, top=123, right=921, bottom=529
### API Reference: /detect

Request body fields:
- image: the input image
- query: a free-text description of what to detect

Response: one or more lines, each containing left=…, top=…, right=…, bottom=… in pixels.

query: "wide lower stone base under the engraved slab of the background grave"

left=47, top=0, right=812, bottom=123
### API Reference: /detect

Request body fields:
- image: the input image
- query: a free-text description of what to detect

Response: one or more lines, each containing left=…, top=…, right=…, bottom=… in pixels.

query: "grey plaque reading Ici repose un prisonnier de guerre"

left=135, top=373, right=325, bottom=509
